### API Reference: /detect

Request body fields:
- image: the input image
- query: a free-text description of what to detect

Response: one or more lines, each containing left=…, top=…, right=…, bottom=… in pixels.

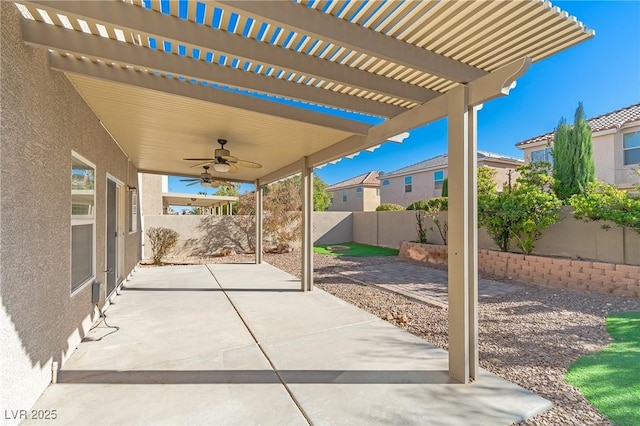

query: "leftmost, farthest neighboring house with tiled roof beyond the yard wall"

left=326, top=171, right=380, bottom=212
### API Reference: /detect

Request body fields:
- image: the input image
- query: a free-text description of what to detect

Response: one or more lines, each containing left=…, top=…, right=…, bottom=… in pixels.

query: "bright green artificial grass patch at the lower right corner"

left=566, top=312, right=640, bottom=426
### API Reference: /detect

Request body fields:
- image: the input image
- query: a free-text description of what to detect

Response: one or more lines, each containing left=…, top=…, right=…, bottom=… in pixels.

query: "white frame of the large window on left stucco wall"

left=69, top=150, right=97, bottom=297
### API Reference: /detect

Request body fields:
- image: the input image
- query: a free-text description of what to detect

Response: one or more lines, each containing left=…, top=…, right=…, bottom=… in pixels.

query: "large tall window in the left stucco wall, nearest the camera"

left=71, top=152, right=96, bottom=293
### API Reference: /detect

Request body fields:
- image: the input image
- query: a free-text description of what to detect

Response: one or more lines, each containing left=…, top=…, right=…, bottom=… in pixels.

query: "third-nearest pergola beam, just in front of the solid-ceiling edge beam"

left=22, top=19, right=405, bottom=116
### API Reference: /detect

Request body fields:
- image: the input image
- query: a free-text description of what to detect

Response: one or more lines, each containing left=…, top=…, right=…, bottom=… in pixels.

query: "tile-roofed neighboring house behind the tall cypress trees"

left=516, top=104, right=640, bottom=189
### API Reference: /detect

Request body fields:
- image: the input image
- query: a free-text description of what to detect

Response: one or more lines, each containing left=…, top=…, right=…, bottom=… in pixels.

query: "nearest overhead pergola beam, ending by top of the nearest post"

left=215, top=0, right=486, bottom=83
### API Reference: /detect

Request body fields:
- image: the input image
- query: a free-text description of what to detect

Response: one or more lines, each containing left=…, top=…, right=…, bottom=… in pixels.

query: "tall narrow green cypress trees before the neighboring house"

left=553, top=103, right=595, bottom=200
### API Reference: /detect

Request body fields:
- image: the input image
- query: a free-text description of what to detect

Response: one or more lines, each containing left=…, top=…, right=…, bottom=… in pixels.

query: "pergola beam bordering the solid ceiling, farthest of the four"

left=49, top=52, right=370, bottom=135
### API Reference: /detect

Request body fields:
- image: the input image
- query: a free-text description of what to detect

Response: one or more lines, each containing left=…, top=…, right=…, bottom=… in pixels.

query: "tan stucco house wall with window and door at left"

left=0, top=1, right=142, bottom=421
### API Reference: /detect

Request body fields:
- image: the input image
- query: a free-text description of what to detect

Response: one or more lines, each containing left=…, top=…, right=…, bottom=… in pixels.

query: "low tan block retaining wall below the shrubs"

left=399, top=241, right=640, bottom=298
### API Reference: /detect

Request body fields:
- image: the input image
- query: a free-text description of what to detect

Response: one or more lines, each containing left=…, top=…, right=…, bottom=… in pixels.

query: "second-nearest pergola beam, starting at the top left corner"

left=29, top=1, right=439, bottom=103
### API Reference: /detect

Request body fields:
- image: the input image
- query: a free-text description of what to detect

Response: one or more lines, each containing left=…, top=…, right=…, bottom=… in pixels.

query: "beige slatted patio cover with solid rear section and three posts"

left=17, top=0, right=594, bottom=383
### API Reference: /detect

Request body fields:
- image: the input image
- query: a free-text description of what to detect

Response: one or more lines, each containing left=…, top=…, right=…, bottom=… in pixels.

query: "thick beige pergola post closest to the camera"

left=447, top=86, right=478, bottom=383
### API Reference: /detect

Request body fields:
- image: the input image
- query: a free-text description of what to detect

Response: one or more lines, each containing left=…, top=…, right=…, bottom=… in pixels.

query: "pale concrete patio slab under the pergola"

left=26, top=264, right=551, bottom=425
